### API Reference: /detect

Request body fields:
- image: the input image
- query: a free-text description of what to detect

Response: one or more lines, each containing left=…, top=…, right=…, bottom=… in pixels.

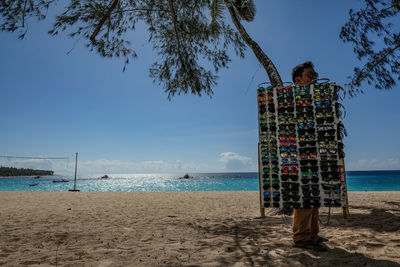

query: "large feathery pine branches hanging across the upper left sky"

left=0, top=0, right=246, bottom=99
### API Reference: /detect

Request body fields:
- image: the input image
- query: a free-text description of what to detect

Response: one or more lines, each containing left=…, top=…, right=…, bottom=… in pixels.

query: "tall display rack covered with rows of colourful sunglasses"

left=257, top=82, right=346, bottom=214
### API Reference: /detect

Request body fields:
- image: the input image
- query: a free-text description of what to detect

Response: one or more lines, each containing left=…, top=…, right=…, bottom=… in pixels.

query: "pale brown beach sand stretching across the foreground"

left=0, top=191, right=400, bottom=266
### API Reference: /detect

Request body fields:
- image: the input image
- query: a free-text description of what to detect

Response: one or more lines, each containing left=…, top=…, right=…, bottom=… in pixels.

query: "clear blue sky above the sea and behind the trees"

left=0, top=0, right=400, bottom=174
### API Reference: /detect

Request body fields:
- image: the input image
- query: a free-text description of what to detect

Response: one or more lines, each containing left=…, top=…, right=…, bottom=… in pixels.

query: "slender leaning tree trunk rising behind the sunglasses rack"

left=224, top=0, right=283, bottom=86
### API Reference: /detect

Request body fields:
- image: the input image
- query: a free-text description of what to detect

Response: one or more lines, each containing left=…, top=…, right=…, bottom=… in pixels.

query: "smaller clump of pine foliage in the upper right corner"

left=340, top=0, right=400, bottom=96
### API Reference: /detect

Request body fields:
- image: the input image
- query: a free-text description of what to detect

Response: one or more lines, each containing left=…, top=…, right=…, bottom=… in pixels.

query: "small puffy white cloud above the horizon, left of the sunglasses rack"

left=219, top=152, right=257, bottom=171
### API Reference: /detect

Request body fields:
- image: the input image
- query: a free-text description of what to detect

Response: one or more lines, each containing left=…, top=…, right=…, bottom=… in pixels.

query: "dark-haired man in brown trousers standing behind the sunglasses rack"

left=292, top=61, right=328, bottom=251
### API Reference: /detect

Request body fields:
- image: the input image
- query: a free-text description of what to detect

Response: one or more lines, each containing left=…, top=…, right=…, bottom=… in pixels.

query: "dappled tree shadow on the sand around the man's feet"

left=185, top=203, right=400, bottom=266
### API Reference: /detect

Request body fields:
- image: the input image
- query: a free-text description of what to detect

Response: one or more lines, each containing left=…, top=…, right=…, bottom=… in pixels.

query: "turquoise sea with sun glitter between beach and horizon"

left=0, top=170, right=400, bottom=192
